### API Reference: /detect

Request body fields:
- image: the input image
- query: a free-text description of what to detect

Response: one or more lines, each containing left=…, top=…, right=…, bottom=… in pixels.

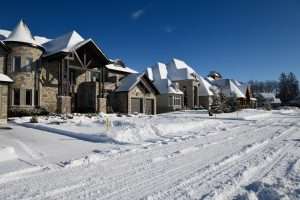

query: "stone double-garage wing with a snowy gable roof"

left=109, top=73, right=159, bottom=114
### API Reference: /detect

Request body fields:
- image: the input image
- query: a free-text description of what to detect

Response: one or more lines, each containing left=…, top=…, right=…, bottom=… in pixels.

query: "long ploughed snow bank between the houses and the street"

left=15, top=113, right=222, bottom=144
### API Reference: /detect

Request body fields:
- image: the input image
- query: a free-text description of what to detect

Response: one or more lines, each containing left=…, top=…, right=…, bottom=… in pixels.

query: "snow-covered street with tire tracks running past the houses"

left=0, top=110, right=300, bottom=199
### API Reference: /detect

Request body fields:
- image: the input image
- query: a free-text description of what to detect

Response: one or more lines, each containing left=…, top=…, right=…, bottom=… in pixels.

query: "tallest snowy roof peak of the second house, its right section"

left=167, top=58, right=199, bottom=81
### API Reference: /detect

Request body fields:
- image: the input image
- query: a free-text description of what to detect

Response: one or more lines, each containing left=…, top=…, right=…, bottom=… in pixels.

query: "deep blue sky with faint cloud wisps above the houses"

left=0, top=0, right=300, bottom=81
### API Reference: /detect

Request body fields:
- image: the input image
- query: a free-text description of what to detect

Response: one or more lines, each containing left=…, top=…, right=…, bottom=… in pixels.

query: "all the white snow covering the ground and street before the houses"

left=0, top=109, right=300, bottom=200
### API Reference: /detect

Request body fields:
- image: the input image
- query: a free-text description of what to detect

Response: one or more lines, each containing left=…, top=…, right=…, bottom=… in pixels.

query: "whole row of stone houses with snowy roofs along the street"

left=0, top=20, right=253, bottom=121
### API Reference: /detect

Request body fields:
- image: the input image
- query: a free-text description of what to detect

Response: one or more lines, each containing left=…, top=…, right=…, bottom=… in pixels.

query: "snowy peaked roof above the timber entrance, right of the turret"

left=43, top=31, right=85, bottom=56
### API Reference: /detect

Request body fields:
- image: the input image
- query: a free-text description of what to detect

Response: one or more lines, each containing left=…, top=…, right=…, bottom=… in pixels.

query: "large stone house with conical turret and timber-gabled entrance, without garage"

left=0, top=21, right=135, bottom=113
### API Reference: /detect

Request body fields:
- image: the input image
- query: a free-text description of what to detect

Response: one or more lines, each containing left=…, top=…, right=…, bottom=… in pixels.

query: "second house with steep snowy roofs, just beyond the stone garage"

left=147, top=58, right=213, bottom=112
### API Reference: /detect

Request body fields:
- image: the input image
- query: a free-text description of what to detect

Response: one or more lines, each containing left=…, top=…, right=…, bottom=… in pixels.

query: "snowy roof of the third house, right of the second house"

left=211, top=79, right=246, bottom=98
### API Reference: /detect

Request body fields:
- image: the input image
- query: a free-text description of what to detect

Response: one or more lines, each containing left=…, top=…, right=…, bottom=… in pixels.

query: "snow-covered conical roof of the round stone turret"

left=2, top=20, right=40, bottom=46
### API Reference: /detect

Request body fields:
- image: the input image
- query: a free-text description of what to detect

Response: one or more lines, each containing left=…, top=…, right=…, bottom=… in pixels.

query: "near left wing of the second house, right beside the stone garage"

left=146, top=63, right=183, bottom=113
